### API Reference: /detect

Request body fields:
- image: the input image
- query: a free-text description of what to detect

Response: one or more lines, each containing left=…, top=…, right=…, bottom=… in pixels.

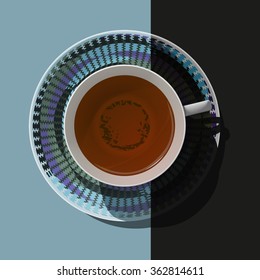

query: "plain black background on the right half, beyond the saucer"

left=151, top=0, right=260, bottom=259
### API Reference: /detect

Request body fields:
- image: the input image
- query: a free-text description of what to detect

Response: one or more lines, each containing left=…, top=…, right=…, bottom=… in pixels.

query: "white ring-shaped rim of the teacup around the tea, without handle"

left=64, top=65, right=186, bottom=187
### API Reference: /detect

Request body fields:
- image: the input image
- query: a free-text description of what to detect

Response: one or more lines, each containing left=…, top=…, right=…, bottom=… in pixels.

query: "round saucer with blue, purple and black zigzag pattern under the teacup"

left=29, top=31, right=219, bottom=221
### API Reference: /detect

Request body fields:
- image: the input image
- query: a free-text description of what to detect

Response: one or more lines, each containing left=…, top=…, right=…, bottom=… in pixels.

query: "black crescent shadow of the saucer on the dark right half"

left=151, top=114, right=230, bottom=228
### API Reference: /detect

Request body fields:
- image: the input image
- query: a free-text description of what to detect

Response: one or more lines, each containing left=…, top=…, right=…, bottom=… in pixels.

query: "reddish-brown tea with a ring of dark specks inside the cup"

left=75, top=76, right=175, bottom=175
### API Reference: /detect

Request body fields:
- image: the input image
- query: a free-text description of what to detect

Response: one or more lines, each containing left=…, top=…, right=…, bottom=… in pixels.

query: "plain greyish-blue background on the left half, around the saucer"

left=0, top=0, right=150, bottom=259
